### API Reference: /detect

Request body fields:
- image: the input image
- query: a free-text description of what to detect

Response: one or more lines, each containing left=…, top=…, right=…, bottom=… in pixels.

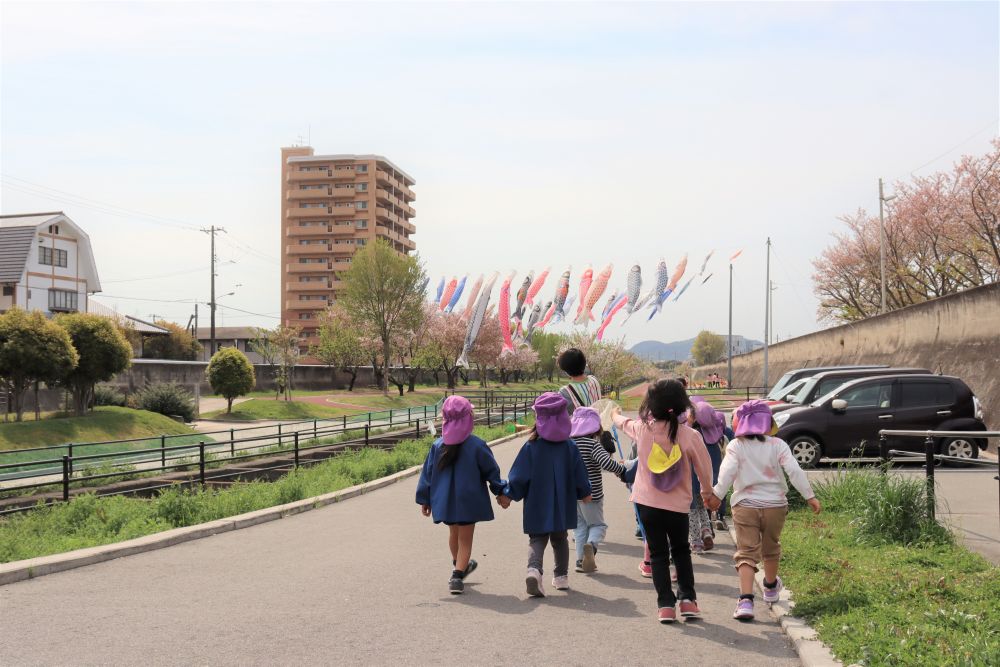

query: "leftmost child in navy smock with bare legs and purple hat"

left=417, top=396, right=504, bottom=595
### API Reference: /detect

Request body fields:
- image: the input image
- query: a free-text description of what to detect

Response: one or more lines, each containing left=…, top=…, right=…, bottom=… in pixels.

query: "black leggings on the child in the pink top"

left=636, top=503, right=697, bottom=608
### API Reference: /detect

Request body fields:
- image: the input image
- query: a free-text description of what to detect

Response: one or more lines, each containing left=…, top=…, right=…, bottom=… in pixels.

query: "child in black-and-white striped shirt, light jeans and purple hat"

left=570, top=407, right=625, bottom=572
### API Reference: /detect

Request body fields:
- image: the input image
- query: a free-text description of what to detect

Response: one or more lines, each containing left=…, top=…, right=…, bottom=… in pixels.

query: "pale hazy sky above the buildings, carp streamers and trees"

left=0, top=2, right=1000, bottom=342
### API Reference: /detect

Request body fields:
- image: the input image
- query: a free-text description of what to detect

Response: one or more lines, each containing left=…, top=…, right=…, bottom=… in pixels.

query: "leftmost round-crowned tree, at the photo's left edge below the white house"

left=0, top=308, right=80, bottom=421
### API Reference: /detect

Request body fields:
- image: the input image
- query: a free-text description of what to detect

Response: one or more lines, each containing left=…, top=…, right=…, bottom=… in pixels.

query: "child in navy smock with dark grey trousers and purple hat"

left=498, top=392, right=591, bottom=597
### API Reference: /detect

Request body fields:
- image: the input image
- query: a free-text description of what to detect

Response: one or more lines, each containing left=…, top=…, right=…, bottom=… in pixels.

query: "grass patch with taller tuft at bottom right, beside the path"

left=781, top=471, right=1000, bottom=665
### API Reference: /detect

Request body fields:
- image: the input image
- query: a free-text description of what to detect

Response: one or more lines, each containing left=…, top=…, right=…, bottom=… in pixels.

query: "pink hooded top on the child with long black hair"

left=614, top=415, right=712, bottom=514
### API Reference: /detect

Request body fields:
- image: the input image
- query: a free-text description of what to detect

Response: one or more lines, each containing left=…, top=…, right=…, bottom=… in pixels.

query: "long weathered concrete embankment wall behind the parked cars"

left=696, top=284, right=1000, bottom=448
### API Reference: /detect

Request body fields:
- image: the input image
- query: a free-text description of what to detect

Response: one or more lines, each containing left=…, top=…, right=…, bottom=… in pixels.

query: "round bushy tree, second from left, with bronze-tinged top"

left=55, top=313, right=132, bottom=415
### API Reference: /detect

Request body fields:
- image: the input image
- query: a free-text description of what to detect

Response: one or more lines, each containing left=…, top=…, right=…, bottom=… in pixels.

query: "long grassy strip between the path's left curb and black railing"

left=0, top=424, right=524, bottom=563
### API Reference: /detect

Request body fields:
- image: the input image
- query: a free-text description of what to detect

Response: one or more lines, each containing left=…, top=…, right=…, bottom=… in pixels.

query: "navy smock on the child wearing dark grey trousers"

left=504, top=438, right=591, bottom=535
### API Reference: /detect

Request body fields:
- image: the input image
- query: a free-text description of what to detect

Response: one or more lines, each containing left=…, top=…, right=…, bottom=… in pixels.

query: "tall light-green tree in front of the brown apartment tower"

left=340, top=239, right=424, bottom=396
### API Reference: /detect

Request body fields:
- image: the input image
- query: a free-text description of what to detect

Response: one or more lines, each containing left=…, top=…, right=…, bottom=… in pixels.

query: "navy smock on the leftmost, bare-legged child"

left=417, top=435, right=504, bottom=524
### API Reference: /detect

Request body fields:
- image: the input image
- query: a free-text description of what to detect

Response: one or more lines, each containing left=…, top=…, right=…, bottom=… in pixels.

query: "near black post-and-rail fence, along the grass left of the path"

left=0, top=402, right=531, bottom=516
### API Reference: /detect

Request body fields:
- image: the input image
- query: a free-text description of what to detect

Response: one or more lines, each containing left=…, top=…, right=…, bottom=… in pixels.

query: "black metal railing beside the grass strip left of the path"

left=0, top=401, right=531, bottom=515
